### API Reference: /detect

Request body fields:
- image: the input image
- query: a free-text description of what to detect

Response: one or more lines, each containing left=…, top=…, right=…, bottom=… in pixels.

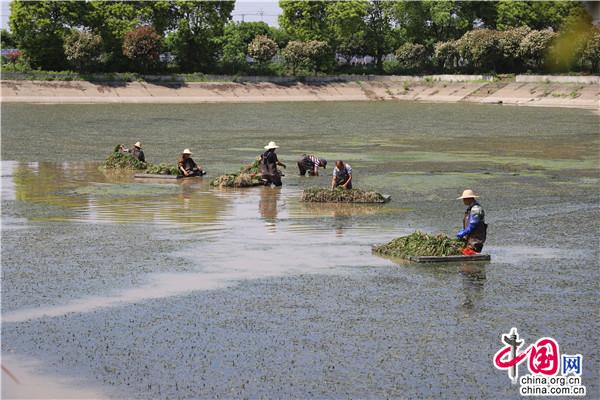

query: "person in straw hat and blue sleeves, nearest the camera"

left=456, top=189, right=487, bottom=256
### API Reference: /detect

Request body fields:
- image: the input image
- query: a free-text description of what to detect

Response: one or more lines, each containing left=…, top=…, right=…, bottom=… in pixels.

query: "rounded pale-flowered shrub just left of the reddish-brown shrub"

left=64, top=29, right=102, bottom=71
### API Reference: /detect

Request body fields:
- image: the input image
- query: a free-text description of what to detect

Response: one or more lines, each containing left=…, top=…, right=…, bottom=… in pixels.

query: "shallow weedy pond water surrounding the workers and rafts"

left=2, top=102, right=600, bottom=398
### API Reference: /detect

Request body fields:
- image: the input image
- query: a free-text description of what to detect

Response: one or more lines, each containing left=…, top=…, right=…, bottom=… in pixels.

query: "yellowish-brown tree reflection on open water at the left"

left=2, top=161, right=228, bottom=231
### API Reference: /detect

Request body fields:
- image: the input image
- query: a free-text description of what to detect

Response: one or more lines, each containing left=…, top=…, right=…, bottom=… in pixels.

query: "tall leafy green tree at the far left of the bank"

left=9, top=0, right=86, bottom=70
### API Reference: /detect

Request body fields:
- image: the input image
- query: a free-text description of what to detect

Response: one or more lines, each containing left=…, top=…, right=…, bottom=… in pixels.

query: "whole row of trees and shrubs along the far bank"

left=1, top=0, right=600, bottom=75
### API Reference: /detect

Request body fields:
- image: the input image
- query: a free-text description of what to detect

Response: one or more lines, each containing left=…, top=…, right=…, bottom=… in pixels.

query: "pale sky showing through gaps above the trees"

left=0, top=0, right=281, bottom=29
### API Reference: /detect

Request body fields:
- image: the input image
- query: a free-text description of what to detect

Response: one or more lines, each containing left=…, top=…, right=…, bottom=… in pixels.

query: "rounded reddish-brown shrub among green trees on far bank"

left=123, top=26, right=162, bottom=72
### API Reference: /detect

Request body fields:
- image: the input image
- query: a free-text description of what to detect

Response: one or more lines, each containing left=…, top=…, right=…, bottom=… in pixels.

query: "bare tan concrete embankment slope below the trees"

left=0, top=76, right=600, bottom=110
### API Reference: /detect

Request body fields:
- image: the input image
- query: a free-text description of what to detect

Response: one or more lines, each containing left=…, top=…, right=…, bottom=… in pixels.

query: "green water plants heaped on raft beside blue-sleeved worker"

left=373, top=231, right=466, bottom=258
